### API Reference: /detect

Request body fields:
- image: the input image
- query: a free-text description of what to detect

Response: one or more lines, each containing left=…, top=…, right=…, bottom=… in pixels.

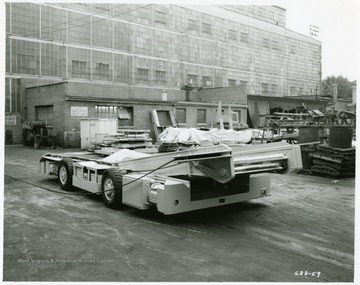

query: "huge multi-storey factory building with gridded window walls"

left=5, top=3, right=321, bottom=145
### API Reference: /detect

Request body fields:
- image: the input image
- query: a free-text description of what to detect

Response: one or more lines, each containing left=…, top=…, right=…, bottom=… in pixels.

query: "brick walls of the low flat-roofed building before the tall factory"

left=26, top=82, right=246, bottom=147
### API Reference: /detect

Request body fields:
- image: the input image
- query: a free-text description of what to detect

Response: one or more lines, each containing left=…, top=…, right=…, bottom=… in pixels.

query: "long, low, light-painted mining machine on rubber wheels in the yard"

left=40, top=142, right=302, bottom=215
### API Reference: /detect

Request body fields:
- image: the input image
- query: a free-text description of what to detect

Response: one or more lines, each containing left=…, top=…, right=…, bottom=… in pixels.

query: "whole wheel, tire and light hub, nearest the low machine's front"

left=101, top=169, right=123, bottom=209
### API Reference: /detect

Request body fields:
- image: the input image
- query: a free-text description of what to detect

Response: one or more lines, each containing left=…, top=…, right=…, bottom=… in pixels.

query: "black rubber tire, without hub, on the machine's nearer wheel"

left=101, top=169, right=123, bottom=210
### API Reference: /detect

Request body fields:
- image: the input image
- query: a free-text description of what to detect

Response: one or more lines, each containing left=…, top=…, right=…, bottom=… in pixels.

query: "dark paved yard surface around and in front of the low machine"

left=3, top=146, right=355, bottom=282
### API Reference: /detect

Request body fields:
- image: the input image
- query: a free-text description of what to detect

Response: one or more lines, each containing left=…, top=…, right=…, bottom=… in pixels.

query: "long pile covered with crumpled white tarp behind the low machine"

left=159, top=127, right=253, bottom=145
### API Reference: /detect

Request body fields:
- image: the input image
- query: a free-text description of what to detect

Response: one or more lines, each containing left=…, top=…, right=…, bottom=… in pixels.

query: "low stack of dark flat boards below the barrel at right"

left=311, top=145, right=356, bottom=178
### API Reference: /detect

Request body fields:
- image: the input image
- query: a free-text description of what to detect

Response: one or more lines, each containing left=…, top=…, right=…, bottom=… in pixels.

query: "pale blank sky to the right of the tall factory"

left=282, top=0, right=360, bottom=81
